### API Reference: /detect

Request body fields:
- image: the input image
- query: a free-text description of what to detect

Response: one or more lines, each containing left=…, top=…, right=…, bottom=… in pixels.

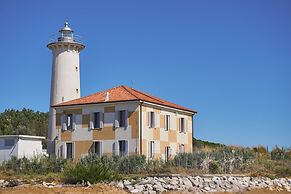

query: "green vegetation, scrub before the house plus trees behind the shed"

left=0, top=109, right=291, bottom=183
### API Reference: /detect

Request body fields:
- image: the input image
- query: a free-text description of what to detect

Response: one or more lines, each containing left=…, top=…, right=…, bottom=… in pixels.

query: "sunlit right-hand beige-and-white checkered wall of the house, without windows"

left=142, top=105, right=192, bottom=159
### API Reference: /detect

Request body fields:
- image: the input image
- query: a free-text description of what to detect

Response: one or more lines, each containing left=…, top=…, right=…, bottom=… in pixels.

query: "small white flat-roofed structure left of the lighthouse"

left=0, top=135, right=45, bottom=163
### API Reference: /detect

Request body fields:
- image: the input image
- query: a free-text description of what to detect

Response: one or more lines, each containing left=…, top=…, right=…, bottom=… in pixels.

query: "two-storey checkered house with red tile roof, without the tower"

left=53, top=86, right=196, bottom=160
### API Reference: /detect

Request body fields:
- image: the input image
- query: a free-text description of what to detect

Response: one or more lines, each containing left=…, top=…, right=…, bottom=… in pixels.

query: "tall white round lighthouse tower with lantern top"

left=47, top=22, right=85, bottom=154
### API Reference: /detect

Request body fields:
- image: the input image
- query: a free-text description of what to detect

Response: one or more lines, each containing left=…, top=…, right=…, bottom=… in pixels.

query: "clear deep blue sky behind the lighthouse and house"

left=0, top=0, right=291, bottom=147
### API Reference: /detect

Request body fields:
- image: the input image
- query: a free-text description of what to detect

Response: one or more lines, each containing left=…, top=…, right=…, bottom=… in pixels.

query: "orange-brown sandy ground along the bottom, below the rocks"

left=0, top=184, right=290, bottom=194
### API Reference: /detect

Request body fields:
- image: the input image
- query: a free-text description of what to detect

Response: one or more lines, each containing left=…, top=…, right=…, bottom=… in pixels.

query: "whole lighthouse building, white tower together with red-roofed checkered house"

left=48, top=23, right=196, bottom=160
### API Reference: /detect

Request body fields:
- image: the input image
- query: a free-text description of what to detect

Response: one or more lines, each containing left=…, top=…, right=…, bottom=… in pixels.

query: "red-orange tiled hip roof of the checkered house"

left=53, top=86, right=196, bottom=113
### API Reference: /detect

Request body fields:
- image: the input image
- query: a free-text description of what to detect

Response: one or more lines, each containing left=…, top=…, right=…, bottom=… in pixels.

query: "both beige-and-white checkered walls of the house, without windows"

left=56, top=103, right=192, bottom=159
